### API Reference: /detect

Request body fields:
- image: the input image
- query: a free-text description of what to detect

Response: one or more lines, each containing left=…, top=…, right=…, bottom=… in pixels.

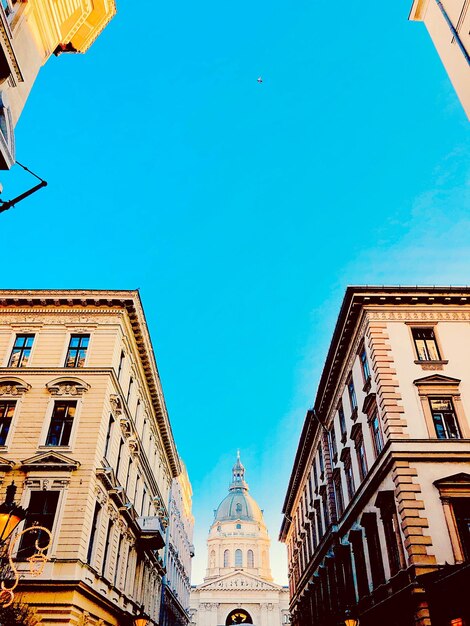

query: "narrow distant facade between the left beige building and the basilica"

left=160, top=463, right=194, bottom=626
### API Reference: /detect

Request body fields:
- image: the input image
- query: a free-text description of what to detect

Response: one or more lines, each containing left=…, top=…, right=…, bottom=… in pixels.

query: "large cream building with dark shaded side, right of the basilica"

left=280, top=287, right=470, bottom=626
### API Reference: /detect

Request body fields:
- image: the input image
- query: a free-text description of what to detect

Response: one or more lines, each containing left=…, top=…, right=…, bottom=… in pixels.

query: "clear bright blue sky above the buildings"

left=0, top=0, right=470, bottom=582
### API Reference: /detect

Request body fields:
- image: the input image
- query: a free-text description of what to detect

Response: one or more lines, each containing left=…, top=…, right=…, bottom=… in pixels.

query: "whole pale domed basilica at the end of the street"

left=191, top=457, right=289, bottom=626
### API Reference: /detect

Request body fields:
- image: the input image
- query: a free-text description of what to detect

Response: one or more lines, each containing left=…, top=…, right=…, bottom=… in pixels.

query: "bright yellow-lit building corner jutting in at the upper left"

left=0, top=0, right=116, bottom=169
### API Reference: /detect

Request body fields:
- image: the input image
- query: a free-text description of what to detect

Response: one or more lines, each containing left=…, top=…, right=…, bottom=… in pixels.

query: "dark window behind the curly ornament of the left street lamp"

left=18, top=491, right=60, bottom=561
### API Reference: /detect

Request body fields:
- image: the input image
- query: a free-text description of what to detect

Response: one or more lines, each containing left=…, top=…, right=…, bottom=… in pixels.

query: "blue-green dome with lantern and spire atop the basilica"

left=214, top=454, right=263, bottom=523
